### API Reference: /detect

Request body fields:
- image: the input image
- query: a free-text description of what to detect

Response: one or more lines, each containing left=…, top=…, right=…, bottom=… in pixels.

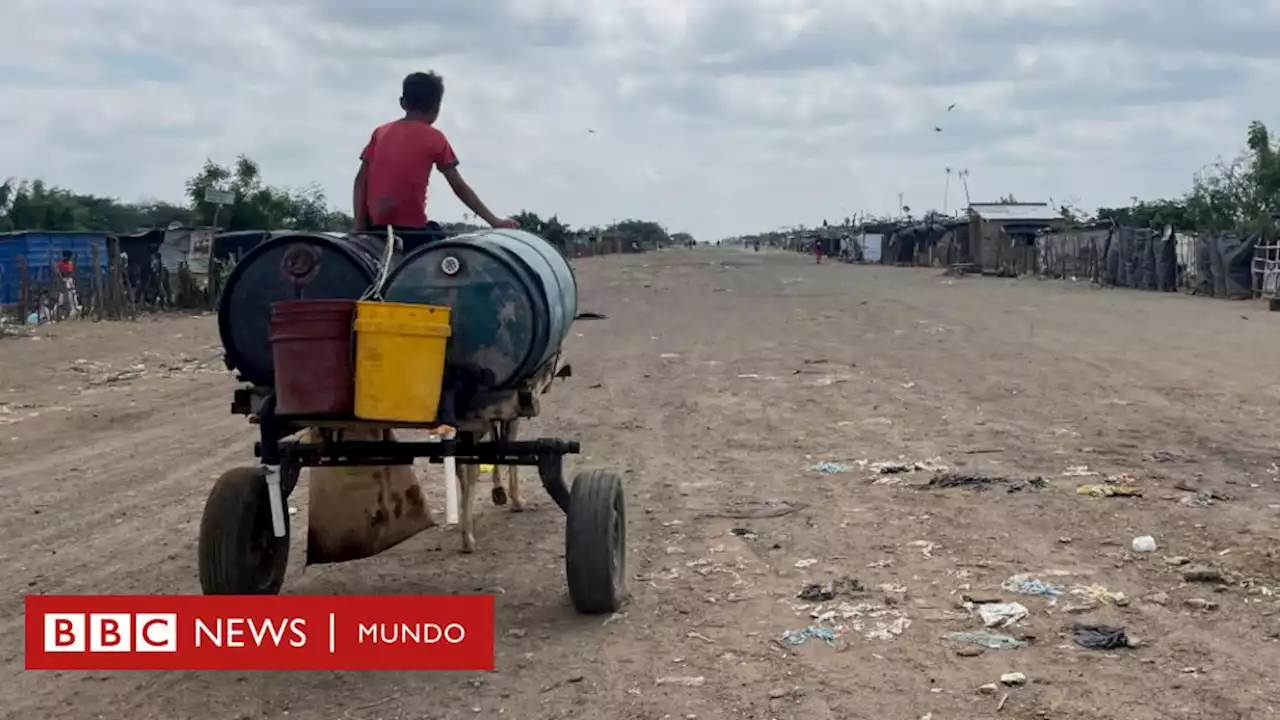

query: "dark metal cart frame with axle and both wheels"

left=200, top=355, right=627, bottom=614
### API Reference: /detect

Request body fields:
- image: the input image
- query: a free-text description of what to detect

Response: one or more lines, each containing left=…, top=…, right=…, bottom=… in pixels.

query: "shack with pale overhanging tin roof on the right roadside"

left=969, top=202, right=1066, bottom=277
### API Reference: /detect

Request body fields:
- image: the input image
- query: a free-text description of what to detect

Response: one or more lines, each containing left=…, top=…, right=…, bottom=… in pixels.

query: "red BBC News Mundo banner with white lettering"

left=26, top=596, right=494, bottom=670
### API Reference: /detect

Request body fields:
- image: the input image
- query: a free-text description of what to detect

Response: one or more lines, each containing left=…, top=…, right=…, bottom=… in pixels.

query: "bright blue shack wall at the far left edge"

left=0, top=231, right=109, bottom=305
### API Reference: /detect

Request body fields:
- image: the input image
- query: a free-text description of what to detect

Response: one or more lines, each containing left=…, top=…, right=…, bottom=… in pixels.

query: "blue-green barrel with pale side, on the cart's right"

left=383, top=229, right=577, bottom=389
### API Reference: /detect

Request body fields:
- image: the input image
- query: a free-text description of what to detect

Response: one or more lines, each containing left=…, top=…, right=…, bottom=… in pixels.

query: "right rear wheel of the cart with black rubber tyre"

left=564, top=470, right=627, bottom=615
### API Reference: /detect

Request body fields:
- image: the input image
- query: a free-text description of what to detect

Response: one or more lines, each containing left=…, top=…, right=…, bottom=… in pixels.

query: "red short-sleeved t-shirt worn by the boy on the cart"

left=360, top=119, right=458, bottom=228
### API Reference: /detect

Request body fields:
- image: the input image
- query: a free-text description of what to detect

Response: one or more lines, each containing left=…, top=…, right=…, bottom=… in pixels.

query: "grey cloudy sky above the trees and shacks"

left=0, top=0, right=1280, bottom=240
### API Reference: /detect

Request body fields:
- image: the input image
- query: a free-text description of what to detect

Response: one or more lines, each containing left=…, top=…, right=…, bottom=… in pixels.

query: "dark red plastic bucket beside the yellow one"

left=270, top=300, right=356, bottom=415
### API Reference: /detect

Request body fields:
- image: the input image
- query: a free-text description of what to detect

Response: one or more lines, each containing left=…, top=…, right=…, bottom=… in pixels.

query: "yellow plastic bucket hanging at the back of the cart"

left=355, top=302, right=451, bottom=424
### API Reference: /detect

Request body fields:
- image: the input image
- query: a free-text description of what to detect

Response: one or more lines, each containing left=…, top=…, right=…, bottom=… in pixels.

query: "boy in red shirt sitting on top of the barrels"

left=352, top=73, right=520, bottom=232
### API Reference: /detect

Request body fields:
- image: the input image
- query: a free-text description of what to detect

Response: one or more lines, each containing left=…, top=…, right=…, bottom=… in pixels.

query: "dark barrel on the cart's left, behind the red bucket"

left=218, top=231, right=399, bottom=387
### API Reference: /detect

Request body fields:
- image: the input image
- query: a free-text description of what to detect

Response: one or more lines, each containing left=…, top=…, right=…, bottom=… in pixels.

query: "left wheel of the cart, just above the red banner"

left=198, top=468, right=289, bottom=594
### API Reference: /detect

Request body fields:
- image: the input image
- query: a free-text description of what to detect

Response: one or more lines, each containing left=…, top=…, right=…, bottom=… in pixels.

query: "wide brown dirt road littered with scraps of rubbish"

left=0, top=250, right=1280, bottom=720
